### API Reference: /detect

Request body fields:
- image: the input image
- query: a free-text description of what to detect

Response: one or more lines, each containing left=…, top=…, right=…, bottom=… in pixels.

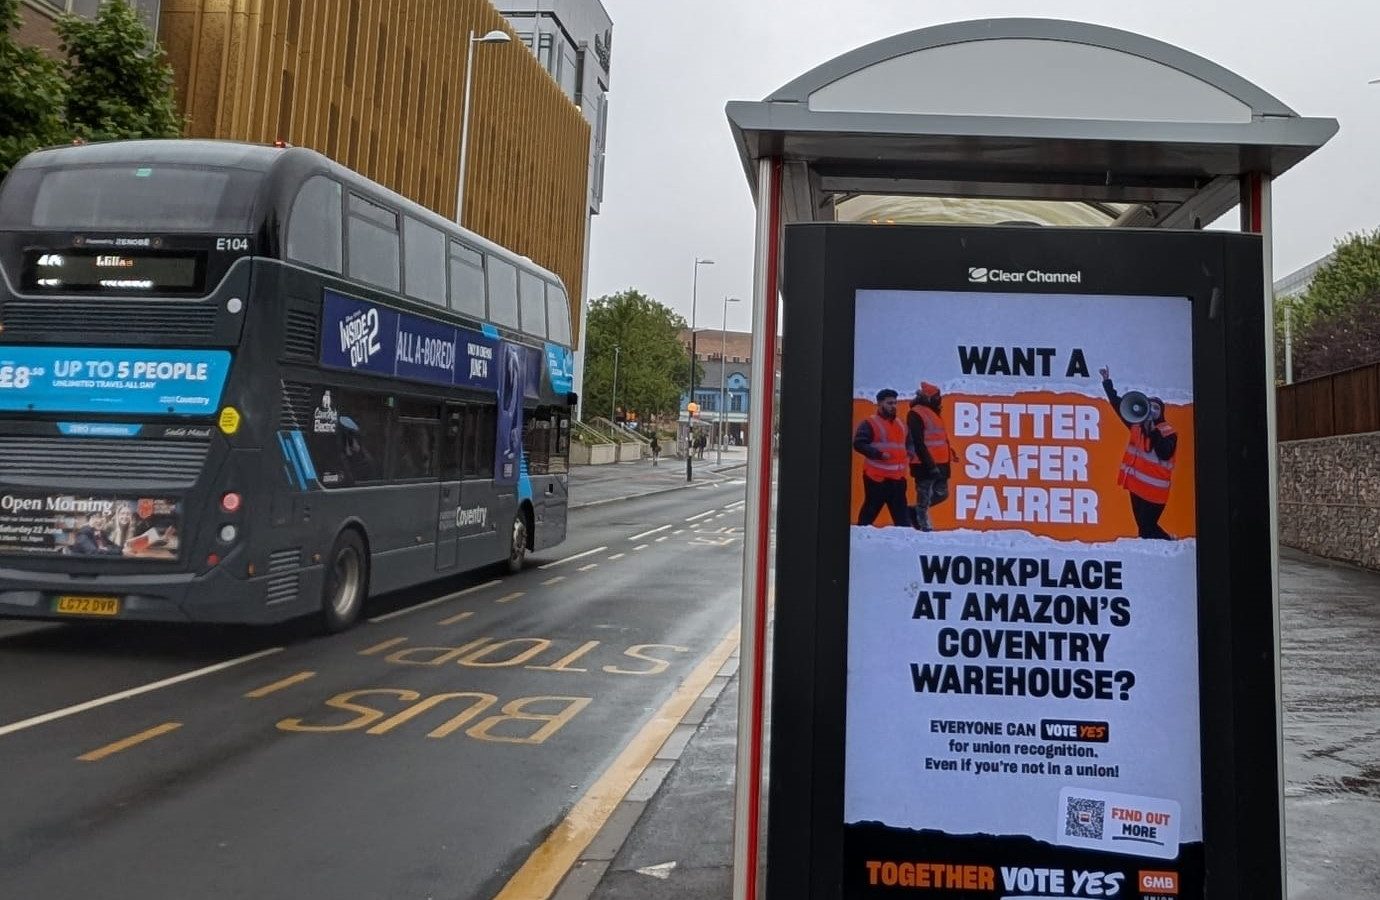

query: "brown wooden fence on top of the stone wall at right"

left=1275, top=363, right=1380, bottom=440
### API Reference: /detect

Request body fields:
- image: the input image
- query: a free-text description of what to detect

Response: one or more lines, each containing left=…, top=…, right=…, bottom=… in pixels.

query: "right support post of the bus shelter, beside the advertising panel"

left=1241, top=173, right=1289, bottom=897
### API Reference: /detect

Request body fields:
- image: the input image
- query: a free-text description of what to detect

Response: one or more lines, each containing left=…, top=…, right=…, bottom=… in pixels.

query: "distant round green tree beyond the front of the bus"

left=584, top=288, right=701, bottom=421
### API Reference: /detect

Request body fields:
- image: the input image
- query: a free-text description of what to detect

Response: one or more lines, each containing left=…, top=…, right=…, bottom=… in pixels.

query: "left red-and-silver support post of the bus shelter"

left=733, top=157, right=781, bottom=900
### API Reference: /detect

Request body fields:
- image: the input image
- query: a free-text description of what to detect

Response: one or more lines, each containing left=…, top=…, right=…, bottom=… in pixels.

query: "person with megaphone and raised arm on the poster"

left=1097, top=366, right=1179, bottom=541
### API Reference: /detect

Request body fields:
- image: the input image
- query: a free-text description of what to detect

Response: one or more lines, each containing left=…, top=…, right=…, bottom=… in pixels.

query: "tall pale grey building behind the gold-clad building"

left=494, top=0, right=613, bottom=414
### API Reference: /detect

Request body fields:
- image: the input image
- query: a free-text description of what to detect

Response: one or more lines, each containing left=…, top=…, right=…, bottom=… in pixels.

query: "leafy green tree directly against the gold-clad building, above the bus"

left=58, top=0, right=184, bottom=141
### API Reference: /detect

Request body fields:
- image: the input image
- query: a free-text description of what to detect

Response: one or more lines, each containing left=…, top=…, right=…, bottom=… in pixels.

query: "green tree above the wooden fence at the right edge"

left=1275, top=229, right=1380, bottom=380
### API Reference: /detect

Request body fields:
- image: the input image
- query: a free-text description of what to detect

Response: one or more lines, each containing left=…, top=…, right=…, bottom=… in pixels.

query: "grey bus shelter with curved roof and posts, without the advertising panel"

left=726, top=19, right=1337, bottom=899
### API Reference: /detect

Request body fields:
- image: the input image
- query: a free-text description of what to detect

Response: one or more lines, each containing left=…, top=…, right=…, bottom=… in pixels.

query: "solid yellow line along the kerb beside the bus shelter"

left=494, top=627, right=738, bottom=900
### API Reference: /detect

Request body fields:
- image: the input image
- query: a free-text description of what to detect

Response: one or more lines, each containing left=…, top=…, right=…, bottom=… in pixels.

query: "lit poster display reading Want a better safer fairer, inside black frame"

left=843, top=290, right=1203, bottom=900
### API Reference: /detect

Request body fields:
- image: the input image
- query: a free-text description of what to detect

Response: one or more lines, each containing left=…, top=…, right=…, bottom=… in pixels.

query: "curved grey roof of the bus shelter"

left=727, top=18, right=1337, bottom=226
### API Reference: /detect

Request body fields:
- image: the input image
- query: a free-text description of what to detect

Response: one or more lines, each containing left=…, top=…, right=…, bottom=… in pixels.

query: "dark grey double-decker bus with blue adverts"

left=0, top=141, right=575, bottom=631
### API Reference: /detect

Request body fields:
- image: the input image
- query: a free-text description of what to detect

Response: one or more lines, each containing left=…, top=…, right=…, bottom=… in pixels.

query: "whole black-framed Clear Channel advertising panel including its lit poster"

left=766, top=222, right=1285, bottom=900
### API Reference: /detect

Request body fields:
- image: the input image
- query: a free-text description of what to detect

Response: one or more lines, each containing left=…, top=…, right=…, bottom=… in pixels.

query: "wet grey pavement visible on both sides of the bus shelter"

left=553, top=472, right=1380, bottom=900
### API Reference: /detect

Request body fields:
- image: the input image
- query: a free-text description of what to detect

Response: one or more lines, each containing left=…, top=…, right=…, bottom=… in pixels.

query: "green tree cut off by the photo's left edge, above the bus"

left=0, top=0, right=68, bottom=178
